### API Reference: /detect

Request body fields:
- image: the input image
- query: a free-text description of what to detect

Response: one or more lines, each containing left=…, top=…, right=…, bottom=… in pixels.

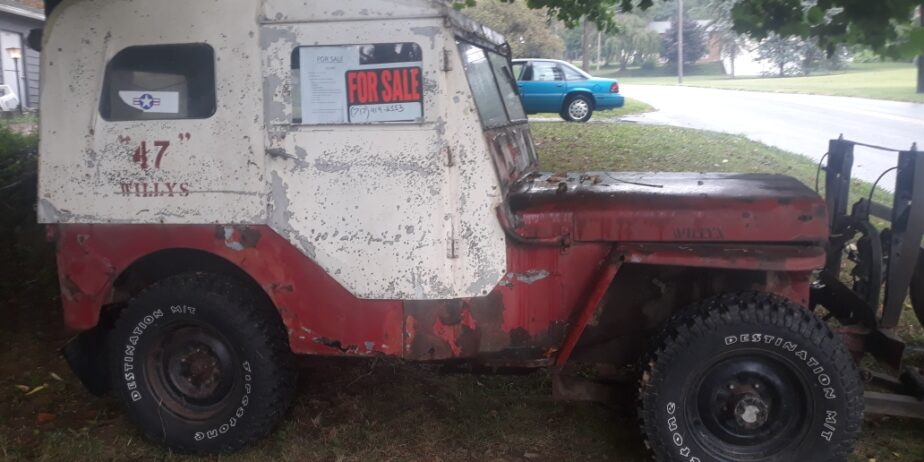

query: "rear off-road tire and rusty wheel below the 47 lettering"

left=109, top=273, right=295, bottom=454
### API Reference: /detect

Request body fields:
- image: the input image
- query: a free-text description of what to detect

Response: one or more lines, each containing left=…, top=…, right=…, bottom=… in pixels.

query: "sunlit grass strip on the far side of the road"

left=620, top=63, right=924, bottom=103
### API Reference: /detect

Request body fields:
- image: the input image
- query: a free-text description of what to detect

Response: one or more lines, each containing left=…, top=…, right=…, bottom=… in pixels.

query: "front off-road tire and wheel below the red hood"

left=639, top=292, right=863, bottom=462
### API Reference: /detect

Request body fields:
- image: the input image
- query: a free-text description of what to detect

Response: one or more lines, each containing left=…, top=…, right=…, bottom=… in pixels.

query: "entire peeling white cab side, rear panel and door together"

left=39, top=0, right=506, bottom=299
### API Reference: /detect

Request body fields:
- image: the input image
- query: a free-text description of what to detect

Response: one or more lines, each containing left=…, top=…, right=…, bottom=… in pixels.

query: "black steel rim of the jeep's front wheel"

left=686, top=352, right=811, bottom=460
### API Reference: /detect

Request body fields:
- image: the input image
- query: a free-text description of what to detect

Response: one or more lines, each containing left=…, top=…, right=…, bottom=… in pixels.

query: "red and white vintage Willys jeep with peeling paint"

left=32, top=0, right=920, bottom=461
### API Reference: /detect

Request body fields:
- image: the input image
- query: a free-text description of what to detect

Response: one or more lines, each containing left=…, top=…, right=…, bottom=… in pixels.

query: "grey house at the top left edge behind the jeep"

left=0, top=0, right=45, bottom=108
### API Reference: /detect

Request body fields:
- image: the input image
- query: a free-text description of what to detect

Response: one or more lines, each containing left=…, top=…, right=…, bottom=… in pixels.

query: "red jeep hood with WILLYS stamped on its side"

left=508, top=172, right=828, bottom=243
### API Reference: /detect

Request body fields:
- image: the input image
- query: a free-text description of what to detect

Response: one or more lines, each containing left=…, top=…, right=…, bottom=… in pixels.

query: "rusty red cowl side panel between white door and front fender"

left=405, top=240, right=612, bottom=362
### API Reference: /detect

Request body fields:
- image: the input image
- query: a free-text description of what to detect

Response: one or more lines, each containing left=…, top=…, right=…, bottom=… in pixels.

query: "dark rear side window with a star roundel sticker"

left=99, top=43, right=216, bottom=122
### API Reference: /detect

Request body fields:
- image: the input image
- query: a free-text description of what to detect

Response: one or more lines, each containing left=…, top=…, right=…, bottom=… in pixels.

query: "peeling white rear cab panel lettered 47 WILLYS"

left=39, top=0, right=266, bottom=224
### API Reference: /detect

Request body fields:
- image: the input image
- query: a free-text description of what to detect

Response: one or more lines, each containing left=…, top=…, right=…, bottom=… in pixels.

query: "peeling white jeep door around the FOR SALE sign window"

left=260, top=0, right=506, bottom=299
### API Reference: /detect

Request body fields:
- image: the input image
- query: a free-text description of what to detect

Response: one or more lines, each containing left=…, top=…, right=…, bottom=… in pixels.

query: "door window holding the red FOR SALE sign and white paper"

left=292, top=43, right=423, bottom=124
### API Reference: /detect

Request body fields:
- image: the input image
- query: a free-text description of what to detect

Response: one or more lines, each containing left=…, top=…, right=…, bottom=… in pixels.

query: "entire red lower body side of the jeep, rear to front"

left=51, top=225, right=819, bottom=366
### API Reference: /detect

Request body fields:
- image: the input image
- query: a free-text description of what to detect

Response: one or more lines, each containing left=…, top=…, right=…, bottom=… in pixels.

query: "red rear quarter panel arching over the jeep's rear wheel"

left=57, top=225, right=403, bottom=355
